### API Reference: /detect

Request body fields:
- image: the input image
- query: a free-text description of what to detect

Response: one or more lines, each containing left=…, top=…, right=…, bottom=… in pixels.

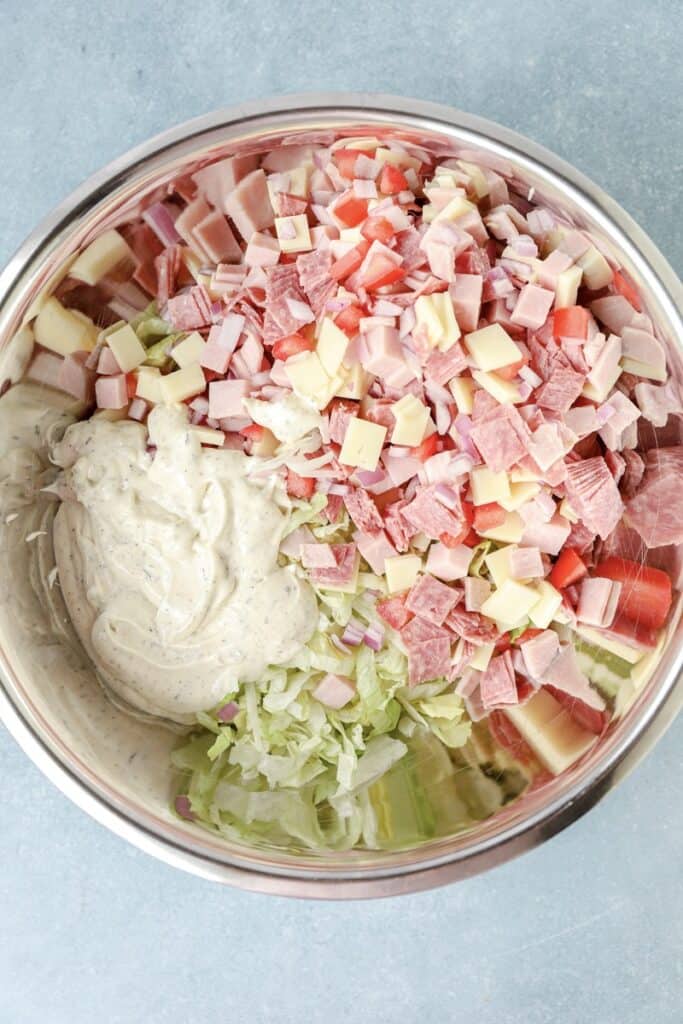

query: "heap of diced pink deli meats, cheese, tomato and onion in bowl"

left=22, top=131, right=683, bottom=819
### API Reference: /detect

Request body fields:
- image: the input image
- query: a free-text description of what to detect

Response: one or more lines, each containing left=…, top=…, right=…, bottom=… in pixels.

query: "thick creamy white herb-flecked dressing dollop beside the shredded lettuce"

left=51, top=407, right=317, bottom=723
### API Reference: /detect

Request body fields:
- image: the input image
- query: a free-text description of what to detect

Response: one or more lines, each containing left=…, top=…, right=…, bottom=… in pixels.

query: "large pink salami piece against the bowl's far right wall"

left=626, top=445, right=683, bottom=548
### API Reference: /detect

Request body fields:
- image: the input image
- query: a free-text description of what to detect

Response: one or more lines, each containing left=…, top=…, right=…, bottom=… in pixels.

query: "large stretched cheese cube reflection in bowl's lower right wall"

left=503, top=689, right=598, bottom=775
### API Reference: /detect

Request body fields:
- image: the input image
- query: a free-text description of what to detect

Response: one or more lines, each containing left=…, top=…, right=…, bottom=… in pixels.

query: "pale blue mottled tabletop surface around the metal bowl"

left=0, top=0, right=683, bottom=1024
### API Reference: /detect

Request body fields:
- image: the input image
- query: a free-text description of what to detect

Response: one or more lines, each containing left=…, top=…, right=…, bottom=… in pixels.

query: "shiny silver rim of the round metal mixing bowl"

left=0, top=92, right=683, bottom=899
